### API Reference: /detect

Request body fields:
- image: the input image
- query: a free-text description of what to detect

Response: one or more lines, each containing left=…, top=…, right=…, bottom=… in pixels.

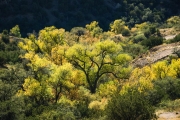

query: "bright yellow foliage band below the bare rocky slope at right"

left=124, top=59, right=180, bottom=93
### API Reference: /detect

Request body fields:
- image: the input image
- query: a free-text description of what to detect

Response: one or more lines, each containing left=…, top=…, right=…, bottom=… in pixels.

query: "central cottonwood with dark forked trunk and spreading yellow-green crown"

left=66, top=40, right=131, bottom=93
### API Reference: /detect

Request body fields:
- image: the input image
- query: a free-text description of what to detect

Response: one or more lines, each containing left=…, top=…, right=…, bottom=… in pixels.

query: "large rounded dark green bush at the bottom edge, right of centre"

left=106, top=90, right=155, bottom=120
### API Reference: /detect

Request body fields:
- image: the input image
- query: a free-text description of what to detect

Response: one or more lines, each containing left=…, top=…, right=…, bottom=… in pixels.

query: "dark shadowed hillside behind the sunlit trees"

left=0, top=0, right=180, bottom=35
